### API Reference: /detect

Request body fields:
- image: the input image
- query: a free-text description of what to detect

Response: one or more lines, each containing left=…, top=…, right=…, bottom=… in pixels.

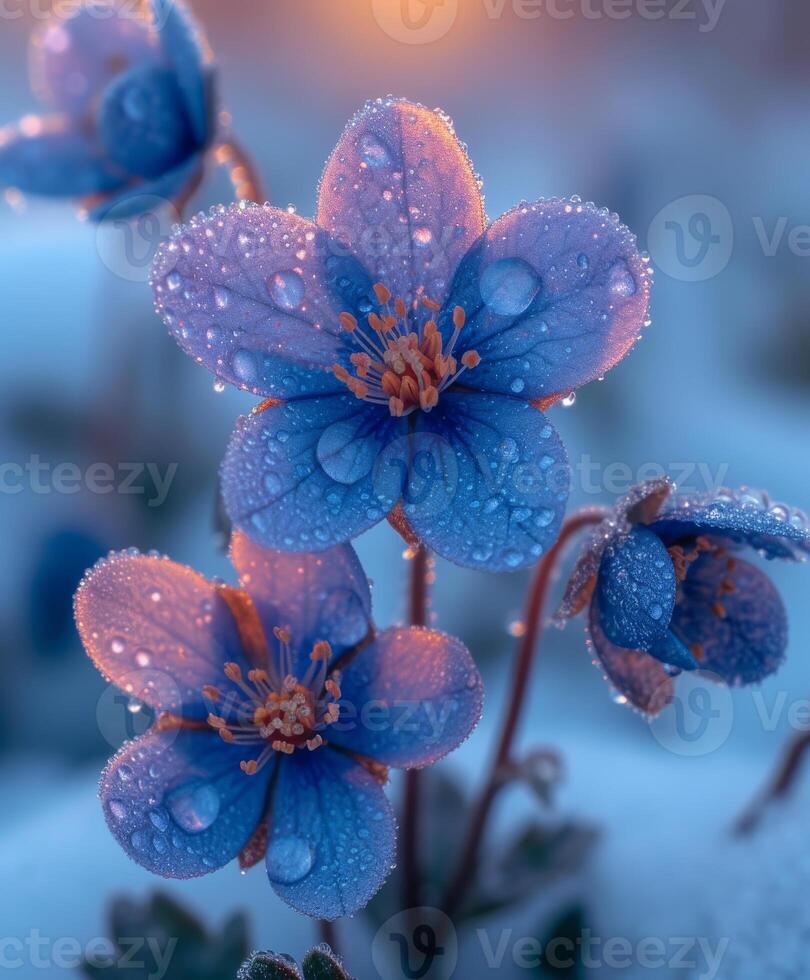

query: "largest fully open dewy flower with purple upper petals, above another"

left=153, top=98, right=650, bottom=570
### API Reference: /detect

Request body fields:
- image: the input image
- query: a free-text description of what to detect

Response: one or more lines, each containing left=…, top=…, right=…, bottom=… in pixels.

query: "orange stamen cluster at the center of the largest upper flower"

left=332, top=282, right=481, bottom=418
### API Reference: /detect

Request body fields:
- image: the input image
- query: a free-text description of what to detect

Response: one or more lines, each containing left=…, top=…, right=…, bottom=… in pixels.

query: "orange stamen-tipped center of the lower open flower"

left=203, top=627, right=341, bottom=776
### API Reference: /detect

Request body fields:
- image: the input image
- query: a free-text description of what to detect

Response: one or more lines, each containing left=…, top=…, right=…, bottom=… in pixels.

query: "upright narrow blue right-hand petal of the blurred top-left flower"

left=151, top=0, right=213, bottom=147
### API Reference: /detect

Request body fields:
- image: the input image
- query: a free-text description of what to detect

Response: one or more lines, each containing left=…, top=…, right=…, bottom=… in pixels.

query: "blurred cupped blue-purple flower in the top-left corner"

left=0, top=0, right=215, bottom=220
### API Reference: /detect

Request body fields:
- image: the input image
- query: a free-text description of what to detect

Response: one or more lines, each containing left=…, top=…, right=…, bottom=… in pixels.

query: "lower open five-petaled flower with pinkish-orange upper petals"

left=76, top=533, right=483, bottom=919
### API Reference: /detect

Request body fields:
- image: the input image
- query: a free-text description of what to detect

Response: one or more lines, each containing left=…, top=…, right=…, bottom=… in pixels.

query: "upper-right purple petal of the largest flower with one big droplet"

left=440, top=199, right=651, bottom=399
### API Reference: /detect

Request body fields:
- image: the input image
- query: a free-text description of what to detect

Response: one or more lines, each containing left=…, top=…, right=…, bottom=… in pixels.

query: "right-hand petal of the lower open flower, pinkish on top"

left=326, top=628, right=484, bottom=769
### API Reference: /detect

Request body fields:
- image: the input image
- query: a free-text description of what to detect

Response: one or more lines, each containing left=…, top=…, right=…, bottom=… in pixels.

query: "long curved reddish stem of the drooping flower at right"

left=442, top=511, right=603, bottom=917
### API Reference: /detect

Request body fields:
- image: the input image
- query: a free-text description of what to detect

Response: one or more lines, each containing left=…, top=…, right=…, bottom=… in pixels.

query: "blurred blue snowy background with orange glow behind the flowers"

left=0, top=0, right=810, bottom=978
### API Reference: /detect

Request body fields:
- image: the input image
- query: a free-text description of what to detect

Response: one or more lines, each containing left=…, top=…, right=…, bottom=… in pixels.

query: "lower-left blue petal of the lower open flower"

left=100, top=730, right=272, bottom=878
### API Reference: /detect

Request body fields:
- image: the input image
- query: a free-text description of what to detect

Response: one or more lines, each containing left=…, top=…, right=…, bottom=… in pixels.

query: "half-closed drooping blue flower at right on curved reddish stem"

left=557, top=480, right=810, bottom=715
